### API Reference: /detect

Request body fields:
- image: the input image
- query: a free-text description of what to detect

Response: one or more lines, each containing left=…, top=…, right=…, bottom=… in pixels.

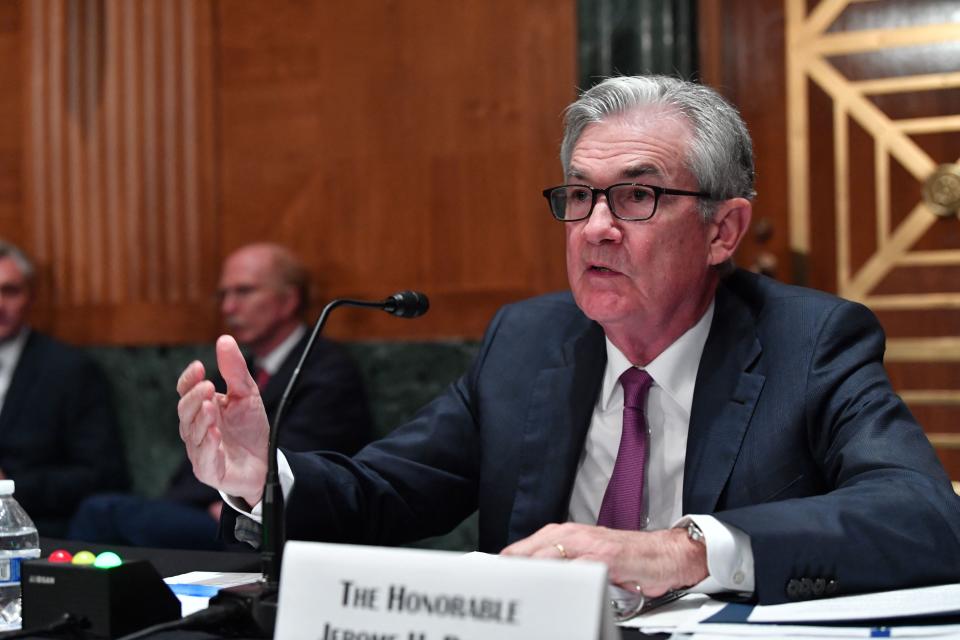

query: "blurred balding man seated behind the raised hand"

left=69, top=243, right=372, bottom=549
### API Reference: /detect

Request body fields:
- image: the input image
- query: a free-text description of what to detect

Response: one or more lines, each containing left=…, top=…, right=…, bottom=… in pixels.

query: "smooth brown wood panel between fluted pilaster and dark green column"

left=217, top=0, right=575, bottom=338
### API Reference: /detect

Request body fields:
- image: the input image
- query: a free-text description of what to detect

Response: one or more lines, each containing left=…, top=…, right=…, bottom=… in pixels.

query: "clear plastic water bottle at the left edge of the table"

left=0, top=480, right=40, bottom=630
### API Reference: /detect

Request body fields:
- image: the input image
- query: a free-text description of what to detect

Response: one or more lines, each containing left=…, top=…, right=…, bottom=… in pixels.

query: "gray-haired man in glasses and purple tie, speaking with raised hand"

left=178, top=77, right=960, bottom=603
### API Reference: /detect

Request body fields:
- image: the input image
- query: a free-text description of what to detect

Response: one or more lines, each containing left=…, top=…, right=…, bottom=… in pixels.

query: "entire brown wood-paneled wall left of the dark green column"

left=7, top=0, right=576, bottom=344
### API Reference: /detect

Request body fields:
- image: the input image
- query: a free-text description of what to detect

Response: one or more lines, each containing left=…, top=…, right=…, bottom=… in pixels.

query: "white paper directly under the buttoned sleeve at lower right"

left=747, top=584, right=960, bottom=622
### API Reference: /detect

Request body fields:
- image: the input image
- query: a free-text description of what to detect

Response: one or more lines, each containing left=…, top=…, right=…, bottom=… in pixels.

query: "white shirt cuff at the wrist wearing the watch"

left=673, top=515, right=754, bottom=594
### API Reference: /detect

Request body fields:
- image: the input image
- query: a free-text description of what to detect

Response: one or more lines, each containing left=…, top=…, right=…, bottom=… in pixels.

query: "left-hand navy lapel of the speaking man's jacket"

left=508, top=324, right=606, bottom=542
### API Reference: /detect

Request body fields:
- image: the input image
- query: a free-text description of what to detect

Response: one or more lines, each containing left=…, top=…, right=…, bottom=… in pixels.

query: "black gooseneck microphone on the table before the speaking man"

left=210, top=290, right=430, bottom=638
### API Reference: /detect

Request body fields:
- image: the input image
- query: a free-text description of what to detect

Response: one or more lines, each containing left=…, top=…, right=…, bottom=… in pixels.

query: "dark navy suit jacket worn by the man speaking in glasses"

left=274, top=271, right=960, bottom=603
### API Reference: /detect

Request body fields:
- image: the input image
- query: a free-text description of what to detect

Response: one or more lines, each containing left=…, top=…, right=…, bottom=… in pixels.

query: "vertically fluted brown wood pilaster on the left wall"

left=21, top=0, right=217, bottom=342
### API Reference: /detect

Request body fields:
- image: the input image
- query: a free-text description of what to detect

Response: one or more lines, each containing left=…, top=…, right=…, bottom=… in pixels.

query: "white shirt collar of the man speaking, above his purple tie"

left=600, top=301, right=714, bottom=415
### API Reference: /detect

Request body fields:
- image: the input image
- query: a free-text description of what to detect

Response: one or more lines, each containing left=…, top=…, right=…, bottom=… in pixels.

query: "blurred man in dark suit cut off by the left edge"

left=0, top=240, right=128, bottom=536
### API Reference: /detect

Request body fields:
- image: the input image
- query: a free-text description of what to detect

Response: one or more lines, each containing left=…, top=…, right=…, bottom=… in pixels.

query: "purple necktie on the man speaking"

left=597, top=367, right=653, bottom=531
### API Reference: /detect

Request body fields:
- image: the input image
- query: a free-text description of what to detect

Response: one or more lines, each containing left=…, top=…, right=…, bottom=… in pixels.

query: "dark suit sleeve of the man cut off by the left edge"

left=14, top=356, right=129, bottom=517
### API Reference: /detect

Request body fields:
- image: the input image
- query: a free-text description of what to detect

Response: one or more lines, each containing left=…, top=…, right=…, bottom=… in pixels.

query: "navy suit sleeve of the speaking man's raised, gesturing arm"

left=255, top=314, right=502, bottom=545
